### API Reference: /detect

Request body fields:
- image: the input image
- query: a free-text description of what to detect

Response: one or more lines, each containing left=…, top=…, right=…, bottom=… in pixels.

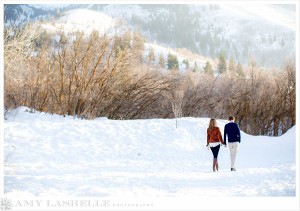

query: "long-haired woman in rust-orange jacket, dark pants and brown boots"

left=206, top=119, right=224, bottom=171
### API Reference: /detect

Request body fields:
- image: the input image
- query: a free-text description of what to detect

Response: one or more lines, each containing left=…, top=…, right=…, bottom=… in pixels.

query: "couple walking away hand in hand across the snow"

left=206, top=116, right=241, bottom=171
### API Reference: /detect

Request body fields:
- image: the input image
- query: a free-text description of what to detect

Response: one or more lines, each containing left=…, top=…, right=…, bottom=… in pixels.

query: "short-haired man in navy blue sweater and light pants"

left=224, top=116, right=241, bottom=171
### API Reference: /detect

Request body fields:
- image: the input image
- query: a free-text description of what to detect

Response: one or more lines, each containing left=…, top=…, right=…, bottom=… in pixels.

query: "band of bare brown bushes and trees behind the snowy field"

left=4, top=23, right=296, bottom=136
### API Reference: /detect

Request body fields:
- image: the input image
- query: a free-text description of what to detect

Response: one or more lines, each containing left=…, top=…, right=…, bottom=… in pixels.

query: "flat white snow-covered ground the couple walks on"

left=4, top=107, right=296, bottom=202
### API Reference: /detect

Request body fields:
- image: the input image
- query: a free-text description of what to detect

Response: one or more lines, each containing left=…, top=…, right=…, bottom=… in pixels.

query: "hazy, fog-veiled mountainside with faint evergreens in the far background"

left=4, top=3, right=296, bottom=68
